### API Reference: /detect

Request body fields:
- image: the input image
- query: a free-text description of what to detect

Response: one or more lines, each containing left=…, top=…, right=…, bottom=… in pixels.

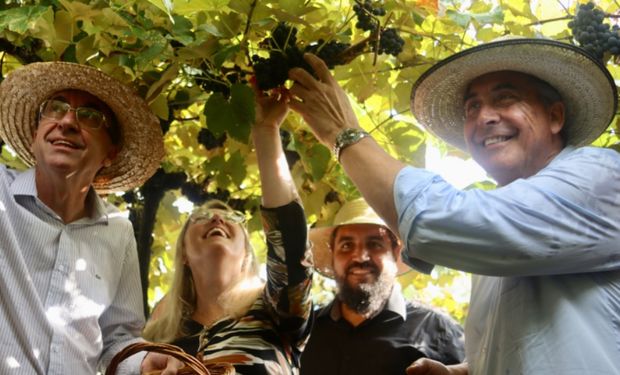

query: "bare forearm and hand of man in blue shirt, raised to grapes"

left=289, top=54, right=405, bottom=233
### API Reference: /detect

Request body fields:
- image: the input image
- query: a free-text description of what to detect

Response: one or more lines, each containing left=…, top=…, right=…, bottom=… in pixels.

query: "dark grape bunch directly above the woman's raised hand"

left=252, top=22, right=312, bottom=90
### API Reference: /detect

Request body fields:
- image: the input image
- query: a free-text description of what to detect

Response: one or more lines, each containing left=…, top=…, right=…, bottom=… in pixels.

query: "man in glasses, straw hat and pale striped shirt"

left=0, top=62, right=176, bottom=374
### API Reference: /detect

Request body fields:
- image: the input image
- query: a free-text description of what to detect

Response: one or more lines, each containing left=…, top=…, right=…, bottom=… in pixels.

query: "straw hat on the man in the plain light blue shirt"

left=411, top=37, right=618, bottom=151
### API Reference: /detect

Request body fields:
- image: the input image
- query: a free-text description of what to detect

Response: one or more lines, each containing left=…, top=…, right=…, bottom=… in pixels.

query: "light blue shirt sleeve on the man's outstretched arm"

left=394, top=148, right=620, bottom=276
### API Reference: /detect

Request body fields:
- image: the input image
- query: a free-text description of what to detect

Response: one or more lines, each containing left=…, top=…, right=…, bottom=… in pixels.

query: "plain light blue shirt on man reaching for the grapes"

left=394, top=147, right=620, bottom=375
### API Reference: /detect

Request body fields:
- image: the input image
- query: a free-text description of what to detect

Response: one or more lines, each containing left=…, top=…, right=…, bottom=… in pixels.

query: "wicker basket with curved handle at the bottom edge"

left=105, top=342, right=235, bottom=375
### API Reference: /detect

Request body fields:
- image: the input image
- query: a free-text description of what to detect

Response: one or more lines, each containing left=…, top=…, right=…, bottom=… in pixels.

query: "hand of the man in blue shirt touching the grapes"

left=289, top=53, right=359, bottom=149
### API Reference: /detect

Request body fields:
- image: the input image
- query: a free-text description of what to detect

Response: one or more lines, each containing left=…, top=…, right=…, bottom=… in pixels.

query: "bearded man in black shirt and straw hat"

left=301, top=199, right=464, bottom=375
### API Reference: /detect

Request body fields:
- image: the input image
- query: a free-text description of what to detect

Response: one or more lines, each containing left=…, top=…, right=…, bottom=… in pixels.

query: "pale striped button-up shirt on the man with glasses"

left=0, top=165, right=144, bottom=375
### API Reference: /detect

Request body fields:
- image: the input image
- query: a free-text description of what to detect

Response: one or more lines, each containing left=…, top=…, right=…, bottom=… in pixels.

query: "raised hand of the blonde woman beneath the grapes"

left=250, top=79, right=290, bottom=130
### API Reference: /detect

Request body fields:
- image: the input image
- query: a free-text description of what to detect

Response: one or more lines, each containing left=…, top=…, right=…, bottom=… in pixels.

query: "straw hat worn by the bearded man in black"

left=309, top=198, right=411, bottom=279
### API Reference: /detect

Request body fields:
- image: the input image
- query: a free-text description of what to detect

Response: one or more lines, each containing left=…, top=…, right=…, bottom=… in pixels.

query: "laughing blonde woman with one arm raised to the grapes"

left=144, top=87, right=312, bottom=375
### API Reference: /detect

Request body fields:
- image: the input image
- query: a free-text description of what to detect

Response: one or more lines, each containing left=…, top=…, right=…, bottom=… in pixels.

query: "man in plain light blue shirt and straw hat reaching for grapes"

left=290, top=38, right=620, bottom=375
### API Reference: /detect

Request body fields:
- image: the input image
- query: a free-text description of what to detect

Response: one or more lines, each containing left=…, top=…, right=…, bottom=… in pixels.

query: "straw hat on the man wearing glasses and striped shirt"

left=0, top=62, right=164, bottom=194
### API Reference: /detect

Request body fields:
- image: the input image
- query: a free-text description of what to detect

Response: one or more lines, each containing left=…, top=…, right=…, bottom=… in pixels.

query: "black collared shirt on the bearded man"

left=301, top=288, right=464, bottom=375
